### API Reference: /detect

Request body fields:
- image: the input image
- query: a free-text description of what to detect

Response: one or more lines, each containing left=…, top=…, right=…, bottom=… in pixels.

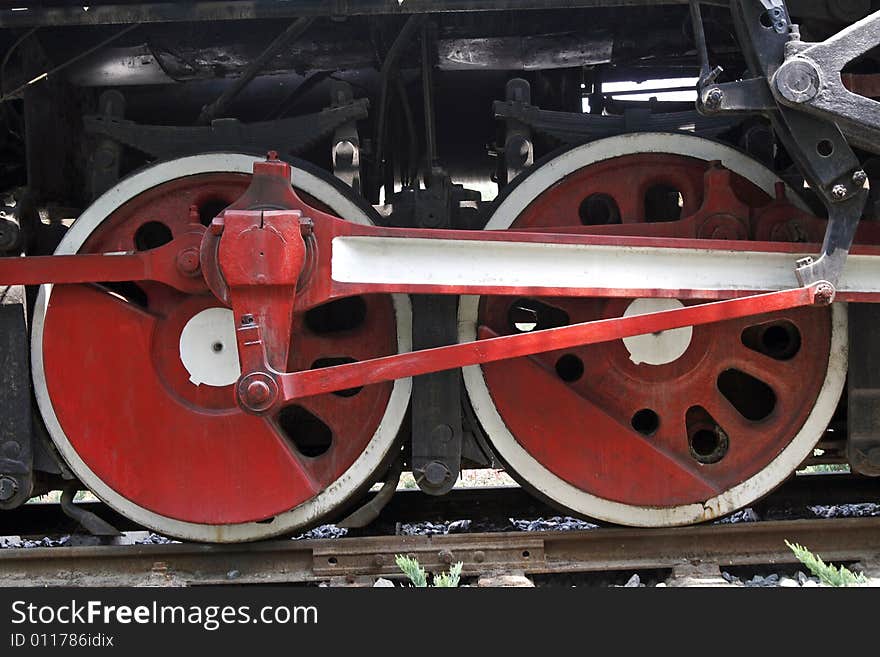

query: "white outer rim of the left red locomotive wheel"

left=31, top=153, right=412, bottom=543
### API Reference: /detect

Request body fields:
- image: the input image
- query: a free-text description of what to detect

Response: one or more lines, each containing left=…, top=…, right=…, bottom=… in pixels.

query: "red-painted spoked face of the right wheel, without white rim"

left=478, top=155, right=840, bottom=508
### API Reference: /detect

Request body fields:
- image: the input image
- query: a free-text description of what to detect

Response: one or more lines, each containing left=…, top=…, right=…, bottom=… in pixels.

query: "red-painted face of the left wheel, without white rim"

left=39, top=168, right=397, bottom=524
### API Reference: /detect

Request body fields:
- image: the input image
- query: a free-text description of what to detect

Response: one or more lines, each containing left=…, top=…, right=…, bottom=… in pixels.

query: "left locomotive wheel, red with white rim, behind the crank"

left=32, top=154, right=411, bottom=542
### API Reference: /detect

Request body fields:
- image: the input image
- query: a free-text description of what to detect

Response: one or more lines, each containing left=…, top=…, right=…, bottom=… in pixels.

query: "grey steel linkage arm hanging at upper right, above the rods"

left=693, top=0, right=868, bottom=285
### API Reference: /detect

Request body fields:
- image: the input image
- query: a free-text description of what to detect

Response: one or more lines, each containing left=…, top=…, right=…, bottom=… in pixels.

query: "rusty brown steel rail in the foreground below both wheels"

left=0, top=518, right=880, bottom=586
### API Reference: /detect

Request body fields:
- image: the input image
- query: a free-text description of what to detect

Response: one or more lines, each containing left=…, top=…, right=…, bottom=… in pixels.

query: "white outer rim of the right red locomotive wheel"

left=458, top=133, right=848, bottom=527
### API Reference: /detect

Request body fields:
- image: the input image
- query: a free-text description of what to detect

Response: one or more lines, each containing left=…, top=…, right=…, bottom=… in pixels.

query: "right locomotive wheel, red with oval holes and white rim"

left=459, top=134, right=847, bottom=526
